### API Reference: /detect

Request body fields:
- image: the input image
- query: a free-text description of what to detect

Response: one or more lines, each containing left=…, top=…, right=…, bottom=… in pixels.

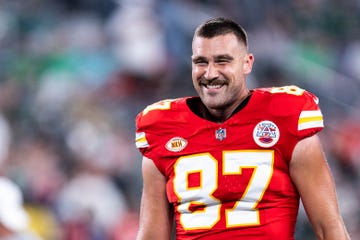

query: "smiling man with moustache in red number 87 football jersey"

left=136, top=18, right=349, bottom=240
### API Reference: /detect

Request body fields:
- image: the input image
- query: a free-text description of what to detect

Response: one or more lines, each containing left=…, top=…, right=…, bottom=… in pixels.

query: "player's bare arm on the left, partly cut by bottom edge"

left=137, top=157, right=172, bottom=240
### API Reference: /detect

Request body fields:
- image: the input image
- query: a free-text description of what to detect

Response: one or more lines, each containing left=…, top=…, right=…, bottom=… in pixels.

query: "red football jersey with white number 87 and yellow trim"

left=136, top=86, right=323, bottom=240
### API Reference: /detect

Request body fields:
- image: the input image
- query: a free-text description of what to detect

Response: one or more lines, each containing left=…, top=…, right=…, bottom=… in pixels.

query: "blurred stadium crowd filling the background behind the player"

left=0, top=0, right=360, bottom=240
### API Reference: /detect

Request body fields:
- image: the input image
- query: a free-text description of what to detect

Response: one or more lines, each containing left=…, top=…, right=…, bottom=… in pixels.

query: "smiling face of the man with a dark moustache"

left=192, top=33, right=254, bottom=117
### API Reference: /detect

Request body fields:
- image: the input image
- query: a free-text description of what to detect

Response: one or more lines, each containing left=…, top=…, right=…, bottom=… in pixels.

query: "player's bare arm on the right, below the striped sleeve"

left=290, top=135, right=348, bottom=239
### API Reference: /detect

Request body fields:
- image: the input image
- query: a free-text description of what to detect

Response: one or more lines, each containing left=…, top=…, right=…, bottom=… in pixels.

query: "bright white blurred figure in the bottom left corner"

left=0, top=177, right=40, bottom=240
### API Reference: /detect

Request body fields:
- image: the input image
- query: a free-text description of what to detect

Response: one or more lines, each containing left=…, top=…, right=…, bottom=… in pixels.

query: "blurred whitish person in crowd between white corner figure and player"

left=56, top=99, right=129, bottom=240
